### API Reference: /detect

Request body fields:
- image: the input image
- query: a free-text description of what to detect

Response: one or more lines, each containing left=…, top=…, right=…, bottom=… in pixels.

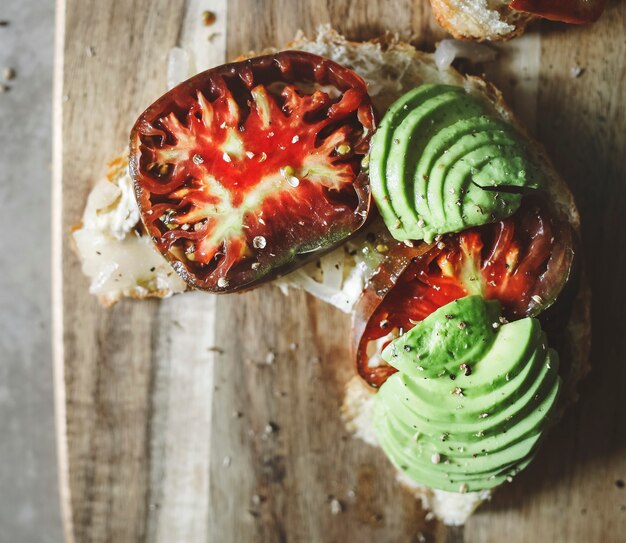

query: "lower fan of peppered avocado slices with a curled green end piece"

left=374, top=296, right=560, bottom=492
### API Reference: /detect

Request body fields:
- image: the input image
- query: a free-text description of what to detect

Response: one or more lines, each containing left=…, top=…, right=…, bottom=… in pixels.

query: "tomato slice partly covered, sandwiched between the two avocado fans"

left=353, top=198, right=574, bottom=387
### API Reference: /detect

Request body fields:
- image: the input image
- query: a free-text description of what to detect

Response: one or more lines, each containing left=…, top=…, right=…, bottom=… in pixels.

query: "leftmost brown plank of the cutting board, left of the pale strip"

left=55, top=0, right=184, bottom=542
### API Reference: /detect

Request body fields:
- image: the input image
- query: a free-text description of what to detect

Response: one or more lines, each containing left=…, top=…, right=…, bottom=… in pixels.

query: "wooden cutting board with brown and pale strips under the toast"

left=53, top=0, right=626, bottom=543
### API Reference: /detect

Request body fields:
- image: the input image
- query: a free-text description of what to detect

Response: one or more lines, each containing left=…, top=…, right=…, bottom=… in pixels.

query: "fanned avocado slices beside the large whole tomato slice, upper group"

left=370, top=85, right=545, bottom=241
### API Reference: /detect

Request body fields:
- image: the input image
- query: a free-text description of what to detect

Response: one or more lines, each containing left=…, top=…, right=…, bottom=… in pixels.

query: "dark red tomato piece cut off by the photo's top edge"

left=509, top=0, right=606, bottom=24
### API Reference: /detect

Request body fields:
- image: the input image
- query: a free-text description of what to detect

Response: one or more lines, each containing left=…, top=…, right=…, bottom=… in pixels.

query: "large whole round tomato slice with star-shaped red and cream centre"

left=130, top=51, right=374, bottom=292
